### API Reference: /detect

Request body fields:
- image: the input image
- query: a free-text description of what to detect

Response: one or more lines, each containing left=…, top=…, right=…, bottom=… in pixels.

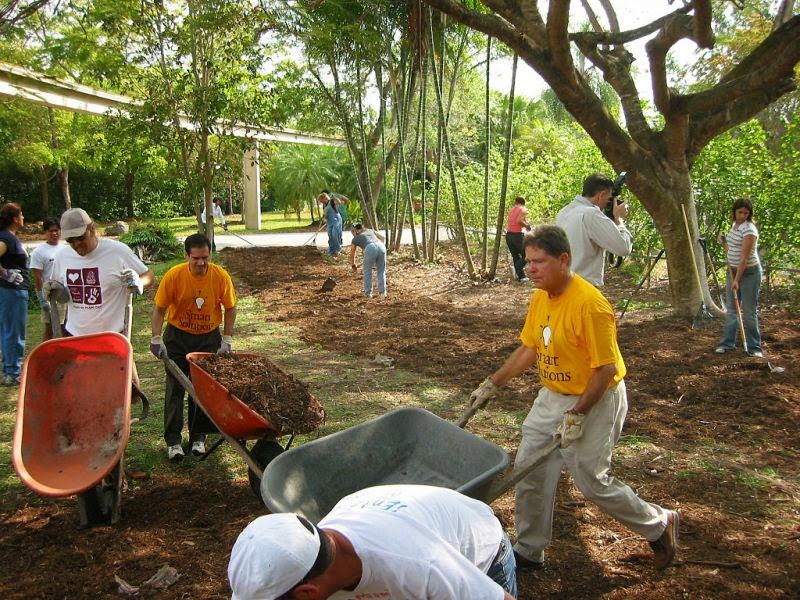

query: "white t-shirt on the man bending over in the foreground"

left=319, top=485, right=505, bottom=600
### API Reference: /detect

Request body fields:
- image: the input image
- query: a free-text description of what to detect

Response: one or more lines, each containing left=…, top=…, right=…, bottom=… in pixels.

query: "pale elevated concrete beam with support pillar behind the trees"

left=0, top=62, right=344, bottom=230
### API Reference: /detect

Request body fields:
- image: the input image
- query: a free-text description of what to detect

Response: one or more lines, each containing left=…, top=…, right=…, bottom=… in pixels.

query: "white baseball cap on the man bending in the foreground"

left=228, top=513, right=320, bottom=600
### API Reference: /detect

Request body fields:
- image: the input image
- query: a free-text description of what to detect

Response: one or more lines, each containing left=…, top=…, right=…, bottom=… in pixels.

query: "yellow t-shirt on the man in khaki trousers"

left=519, top=275, right=626, bottom=396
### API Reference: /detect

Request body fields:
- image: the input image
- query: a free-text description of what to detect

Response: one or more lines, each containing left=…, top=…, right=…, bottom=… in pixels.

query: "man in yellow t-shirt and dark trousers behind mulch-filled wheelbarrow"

left=150, top=233, right=236, bottom=461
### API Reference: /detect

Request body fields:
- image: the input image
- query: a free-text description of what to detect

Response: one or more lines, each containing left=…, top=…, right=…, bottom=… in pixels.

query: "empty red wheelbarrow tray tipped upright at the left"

left=12, top=332, right=133, bottom=497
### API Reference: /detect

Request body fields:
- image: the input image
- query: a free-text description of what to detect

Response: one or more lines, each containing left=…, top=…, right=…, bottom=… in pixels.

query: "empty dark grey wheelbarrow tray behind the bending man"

left=261, top=408, right=509, bottom=523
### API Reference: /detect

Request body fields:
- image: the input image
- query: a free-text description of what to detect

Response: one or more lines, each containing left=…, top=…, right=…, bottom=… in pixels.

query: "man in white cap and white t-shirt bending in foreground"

left=228, top=485, right=517, bottom=600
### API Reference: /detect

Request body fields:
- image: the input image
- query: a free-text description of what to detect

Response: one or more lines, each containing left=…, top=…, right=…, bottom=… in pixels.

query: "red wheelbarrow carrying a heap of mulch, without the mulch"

left=161, top=352, right=294, bottom=499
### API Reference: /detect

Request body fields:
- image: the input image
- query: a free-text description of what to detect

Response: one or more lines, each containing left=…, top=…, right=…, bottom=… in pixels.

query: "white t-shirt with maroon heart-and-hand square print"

left=53, top=238, right=148, bottom=335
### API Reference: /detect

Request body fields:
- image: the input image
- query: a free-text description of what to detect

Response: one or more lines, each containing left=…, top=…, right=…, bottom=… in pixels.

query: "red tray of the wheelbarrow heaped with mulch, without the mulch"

left=186, top=352, right=280, bottom=440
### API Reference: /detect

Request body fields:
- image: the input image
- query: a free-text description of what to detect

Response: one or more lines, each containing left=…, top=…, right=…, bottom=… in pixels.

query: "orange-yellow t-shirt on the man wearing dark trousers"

left=155, top=263, right=236, bottom=335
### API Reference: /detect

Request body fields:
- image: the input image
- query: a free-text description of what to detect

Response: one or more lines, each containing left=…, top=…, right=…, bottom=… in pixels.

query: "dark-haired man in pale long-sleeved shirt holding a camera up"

left=556, top=173, right=633, bottom=287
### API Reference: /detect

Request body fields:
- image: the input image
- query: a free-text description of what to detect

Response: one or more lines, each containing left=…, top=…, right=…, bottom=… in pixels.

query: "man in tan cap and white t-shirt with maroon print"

left=42, top=208, right=154, bottom=335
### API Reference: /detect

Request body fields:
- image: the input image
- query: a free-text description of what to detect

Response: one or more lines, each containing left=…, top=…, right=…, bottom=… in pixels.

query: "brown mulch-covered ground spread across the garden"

left=0, top=248, right=800, bottom=600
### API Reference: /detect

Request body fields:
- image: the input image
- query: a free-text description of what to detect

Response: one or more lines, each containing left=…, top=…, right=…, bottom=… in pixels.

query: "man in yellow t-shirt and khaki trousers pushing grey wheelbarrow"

left=470, top=226, right=679, bottom=569
